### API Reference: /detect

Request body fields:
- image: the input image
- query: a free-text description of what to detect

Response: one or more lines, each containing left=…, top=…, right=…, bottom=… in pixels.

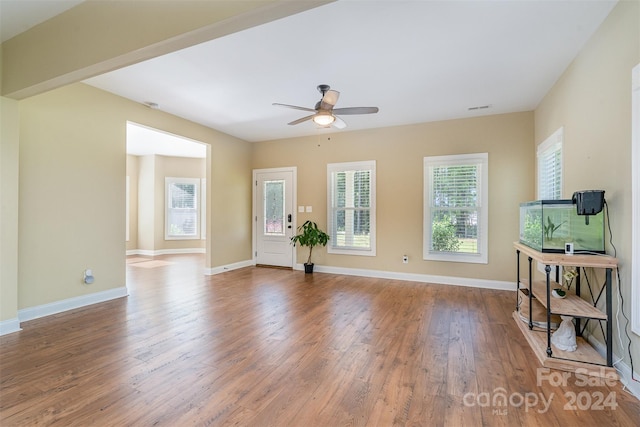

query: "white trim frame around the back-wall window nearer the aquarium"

left=422, top=153, right=489, bottom=264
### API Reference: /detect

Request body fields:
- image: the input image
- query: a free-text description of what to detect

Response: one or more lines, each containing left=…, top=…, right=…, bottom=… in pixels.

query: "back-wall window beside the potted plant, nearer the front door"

left=327, top=161, right=376, bottom=256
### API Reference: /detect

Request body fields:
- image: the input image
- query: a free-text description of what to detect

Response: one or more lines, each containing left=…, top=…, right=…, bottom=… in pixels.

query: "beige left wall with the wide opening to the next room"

left=16, top=84, right=251, bottom=308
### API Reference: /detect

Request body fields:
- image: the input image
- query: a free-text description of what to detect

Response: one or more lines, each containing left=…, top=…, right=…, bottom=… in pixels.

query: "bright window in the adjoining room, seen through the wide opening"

left=165, top=178, right=200, bottom=240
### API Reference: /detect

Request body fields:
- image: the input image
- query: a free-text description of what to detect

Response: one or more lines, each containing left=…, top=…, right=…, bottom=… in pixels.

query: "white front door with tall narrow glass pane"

left=253, top=168, right=296, bottom=267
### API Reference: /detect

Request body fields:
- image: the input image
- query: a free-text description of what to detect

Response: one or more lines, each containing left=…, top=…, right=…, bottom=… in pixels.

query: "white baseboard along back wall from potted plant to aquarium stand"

left=295, top=264, right=515, bottom=291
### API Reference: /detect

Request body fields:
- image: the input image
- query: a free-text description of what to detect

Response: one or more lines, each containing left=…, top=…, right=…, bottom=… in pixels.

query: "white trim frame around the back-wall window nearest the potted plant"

left=327, top=160, right=376, bottom=256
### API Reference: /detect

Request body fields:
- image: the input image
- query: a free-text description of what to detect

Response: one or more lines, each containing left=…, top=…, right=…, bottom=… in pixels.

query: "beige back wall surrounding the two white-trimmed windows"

left=253, top=113, right=534, bottom=281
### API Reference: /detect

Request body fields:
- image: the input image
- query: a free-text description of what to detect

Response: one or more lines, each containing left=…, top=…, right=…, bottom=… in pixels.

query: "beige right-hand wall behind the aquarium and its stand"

left=535, top=1, right=640, bottom=376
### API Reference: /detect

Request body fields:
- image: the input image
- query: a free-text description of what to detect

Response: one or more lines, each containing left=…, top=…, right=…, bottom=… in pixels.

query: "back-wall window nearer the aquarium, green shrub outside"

left=423, top=153, right=489, bottom=264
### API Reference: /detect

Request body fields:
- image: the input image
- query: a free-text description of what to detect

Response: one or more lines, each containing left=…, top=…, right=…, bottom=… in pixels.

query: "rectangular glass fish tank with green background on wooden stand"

left=520, top=200, right=605, bottom=254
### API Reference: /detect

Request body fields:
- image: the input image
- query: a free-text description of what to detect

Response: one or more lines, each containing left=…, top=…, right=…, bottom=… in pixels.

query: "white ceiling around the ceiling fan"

left=1, top=0, right=616, bottom=148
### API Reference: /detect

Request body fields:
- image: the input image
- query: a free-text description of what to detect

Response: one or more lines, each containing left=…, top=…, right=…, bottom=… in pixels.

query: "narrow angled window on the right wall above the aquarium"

left=537, top=128, right=563, bottom=200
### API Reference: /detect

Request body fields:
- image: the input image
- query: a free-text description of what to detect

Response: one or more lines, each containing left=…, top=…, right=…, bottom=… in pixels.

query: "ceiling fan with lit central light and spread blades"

left=273, top=85, right=378, bottom=129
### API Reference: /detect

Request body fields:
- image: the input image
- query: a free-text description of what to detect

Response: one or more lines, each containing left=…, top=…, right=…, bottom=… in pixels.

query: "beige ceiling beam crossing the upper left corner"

left=0, top=0, right=335, bottom=99
